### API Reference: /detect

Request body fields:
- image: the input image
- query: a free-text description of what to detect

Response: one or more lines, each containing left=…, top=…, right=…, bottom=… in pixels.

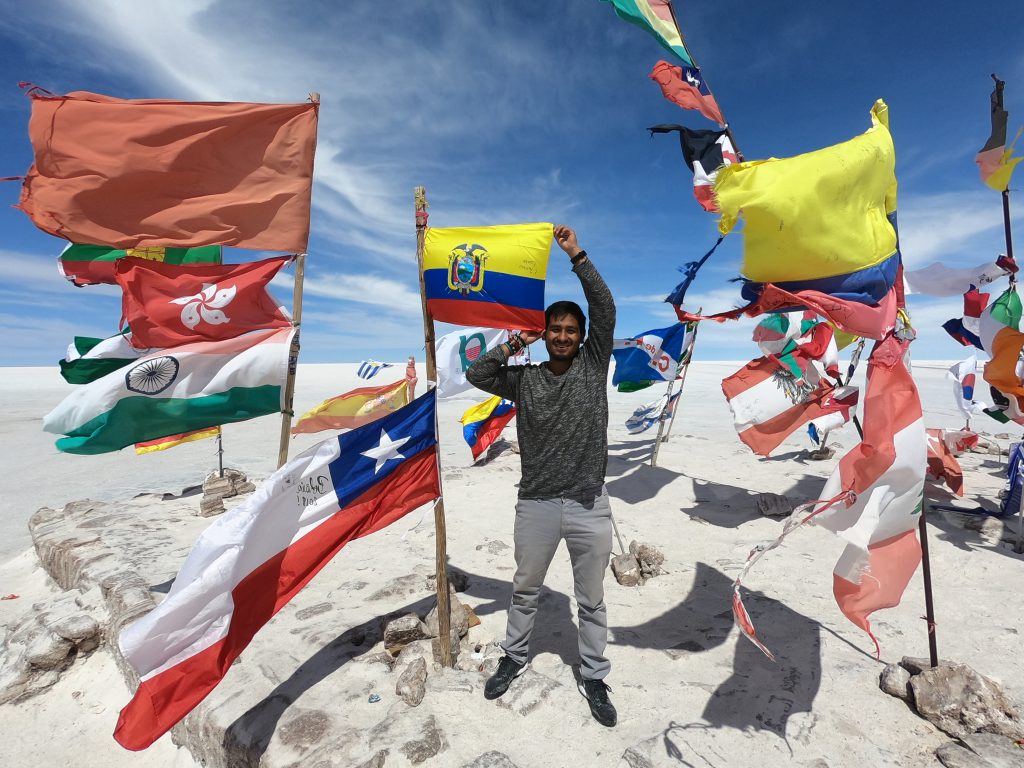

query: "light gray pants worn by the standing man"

left=502, top=486, right=611, bottom=680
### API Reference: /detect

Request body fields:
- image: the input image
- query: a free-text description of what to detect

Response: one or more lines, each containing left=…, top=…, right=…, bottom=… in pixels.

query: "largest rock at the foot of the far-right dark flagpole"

left=910, top=664, right=1024, bottom=739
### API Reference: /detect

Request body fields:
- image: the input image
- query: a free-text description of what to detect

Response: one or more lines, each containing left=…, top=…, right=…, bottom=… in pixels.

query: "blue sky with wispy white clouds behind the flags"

left=0, top=0, right=1024, bottom=366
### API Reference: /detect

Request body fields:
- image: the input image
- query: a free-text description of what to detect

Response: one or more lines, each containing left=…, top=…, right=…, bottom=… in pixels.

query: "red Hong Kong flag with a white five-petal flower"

left=114, top=256, right=292, bottom=349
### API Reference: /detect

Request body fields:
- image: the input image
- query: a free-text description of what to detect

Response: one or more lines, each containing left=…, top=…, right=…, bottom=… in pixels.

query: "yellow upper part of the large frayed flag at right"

left=715, top=99, right=896, bottom=283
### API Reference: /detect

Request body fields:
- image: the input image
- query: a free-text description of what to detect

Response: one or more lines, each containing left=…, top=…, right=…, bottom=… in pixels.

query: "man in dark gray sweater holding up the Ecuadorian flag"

left=466, top=225, right=616, bottom=727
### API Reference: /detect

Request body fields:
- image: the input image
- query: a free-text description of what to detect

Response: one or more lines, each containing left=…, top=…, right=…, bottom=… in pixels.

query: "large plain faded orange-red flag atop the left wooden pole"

left=17, top=88, right=319, bottom=253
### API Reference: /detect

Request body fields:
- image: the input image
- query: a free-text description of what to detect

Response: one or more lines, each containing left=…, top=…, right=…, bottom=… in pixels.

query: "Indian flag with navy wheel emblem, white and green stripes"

left=43, top=328, right=295, bottom=454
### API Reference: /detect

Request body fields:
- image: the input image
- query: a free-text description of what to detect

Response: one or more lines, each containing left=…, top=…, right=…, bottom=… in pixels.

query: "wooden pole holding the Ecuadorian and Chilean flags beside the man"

left=413, top=186, right=455, bottom=667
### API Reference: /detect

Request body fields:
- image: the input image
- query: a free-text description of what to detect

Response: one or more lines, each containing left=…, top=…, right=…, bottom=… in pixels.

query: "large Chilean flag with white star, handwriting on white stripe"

left=114, top=391, right=440, bottom=750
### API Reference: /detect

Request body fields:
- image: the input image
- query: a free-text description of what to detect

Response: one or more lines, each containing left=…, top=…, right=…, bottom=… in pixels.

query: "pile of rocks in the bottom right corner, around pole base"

left=879, top=656, right=1024, bottom=768
